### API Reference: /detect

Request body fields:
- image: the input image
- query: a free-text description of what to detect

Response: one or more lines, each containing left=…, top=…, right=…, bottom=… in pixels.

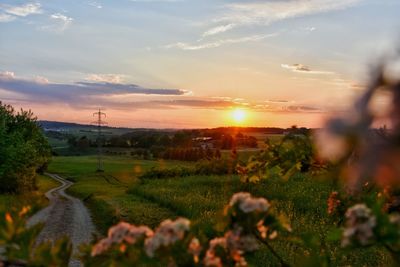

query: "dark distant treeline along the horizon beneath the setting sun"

left=46, top=124, right=309, bottom=161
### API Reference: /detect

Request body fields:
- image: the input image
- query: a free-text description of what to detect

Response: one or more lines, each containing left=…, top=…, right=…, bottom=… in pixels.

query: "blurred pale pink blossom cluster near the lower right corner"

left=342, top=204, right=376, bottom=247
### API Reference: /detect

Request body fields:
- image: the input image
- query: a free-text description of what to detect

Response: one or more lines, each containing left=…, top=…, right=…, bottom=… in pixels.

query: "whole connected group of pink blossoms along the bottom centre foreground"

left=88, top=192, right=280, bottom=267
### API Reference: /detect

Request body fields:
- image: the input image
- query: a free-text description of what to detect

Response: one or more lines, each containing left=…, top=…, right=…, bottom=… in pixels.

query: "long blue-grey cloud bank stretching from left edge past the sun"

left=0, top=72, right=324, bottom=113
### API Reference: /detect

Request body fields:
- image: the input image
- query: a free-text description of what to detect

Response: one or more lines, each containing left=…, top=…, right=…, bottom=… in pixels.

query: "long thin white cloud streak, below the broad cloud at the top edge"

left=164, top=33, right=277, bottom=50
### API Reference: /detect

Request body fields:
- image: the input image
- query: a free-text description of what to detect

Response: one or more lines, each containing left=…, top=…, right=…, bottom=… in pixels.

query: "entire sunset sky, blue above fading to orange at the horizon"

left=0, top=0, right=400, bottom=128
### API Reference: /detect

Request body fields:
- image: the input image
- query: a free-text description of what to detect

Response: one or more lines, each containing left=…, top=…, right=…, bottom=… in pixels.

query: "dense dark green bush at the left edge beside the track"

left=0, top=102, right=50, bottom=192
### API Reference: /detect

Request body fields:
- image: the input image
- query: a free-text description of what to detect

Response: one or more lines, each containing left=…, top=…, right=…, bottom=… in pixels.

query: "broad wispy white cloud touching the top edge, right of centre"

left=206, top=0, right=362, bottom=34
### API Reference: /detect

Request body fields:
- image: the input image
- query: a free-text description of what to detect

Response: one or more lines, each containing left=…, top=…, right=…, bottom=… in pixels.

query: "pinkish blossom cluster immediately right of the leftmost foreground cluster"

left=145, top=218, right=190, bottom=257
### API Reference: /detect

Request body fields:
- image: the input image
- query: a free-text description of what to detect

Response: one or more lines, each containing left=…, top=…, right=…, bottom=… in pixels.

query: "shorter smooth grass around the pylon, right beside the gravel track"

left=49, top=156, right=189, bottom=233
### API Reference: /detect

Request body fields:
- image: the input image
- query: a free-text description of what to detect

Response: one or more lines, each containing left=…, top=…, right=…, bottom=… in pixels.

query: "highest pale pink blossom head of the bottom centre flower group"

left=229, top=192, right=270, bottom=213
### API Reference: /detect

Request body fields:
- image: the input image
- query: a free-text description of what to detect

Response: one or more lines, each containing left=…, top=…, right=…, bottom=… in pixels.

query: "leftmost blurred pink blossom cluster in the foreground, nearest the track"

left=91, top=222, right=153, bottom=256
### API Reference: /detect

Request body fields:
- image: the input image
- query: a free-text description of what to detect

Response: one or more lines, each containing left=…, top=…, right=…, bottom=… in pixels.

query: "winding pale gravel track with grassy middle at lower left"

left=28, top=174, right=96, bottom=267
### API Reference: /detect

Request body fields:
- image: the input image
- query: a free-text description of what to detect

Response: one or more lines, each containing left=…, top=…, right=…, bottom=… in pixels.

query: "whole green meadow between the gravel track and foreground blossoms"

left=49, top=156, right=390, bottom=266
